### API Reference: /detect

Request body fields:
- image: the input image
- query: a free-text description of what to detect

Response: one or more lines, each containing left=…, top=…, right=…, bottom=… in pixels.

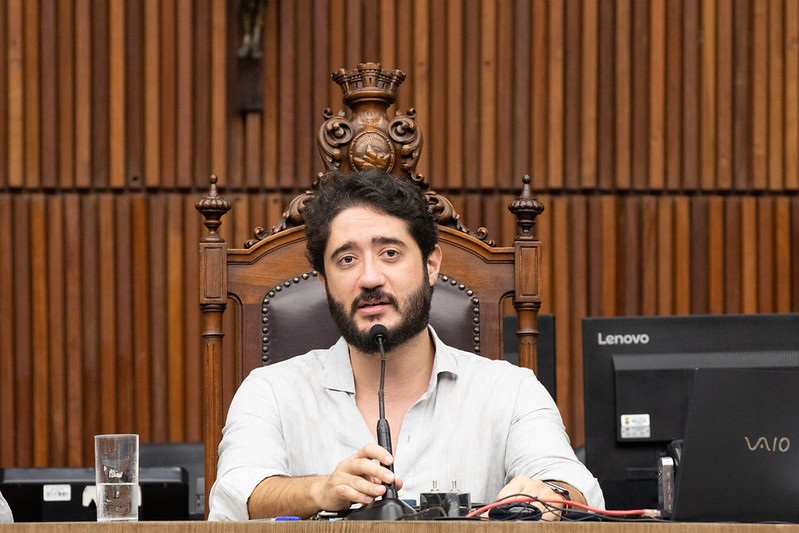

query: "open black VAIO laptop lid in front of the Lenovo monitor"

left=671, top=368, right=799, bottom=523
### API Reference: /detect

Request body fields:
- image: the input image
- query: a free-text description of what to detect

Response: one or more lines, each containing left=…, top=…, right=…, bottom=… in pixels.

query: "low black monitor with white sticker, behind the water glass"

left=0, top=467, right=189, bottom=522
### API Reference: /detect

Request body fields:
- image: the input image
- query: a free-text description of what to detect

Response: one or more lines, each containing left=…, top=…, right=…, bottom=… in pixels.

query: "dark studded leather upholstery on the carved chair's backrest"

left=261, top=272, right=480, bottom=364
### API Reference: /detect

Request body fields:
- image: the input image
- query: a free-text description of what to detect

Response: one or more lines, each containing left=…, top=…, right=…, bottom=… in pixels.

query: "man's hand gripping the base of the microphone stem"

left=311, top=443, right=402, bottom=511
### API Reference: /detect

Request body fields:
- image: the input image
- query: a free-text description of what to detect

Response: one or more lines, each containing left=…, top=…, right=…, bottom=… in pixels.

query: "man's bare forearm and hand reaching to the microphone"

left=247, top=443, right=402, bottom=519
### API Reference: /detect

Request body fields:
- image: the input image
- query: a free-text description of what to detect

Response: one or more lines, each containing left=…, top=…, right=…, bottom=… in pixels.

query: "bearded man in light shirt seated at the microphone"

left=209, top=170, right=604, bottom=520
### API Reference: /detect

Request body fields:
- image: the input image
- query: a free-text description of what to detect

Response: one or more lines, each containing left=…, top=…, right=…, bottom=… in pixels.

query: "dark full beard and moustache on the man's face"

left=327, top=272, right=433, bottom=354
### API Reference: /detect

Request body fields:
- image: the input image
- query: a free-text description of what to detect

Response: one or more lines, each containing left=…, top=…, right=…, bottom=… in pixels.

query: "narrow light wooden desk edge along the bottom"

left=0, top=521, right=799, bottom=533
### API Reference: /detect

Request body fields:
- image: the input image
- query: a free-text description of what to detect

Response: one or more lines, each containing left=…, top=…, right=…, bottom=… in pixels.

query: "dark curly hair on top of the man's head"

left=303, top=169, right=438, bottom=275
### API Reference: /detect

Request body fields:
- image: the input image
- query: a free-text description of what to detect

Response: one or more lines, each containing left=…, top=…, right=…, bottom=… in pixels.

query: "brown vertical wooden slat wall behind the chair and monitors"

left=0, top=0, right=799, bottom=466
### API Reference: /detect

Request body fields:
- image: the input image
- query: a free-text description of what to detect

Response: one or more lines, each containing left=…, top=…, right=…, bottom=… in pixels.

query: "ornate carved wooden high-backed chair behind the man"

left=197, top=63, right=543, bottom=512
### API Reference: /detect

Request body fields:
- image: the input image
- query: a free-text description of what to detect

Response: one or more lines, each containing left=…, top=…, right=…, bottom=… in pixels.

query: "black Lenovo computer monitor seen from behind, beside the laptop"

left=582, top=313, right=799, bottom=509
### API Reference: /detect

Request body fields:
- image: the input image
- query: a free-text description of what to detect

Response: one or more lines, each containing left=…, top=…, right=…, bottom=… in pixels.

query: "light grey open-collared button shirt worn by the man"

left=209, top=328, right=604, bottom=520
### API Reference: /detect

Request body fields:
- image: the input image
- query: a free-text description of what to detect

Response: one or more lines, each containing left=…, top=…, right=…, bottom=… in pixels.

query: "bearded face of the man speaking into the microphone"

left=323, top=207, right=441, bottom=353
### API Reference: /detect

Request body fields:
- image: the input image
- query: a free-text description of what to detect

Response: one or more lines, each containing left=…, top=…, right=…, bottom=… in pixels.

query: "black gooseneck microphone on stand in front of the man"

left=346, top=324, right=416, bottom=520
